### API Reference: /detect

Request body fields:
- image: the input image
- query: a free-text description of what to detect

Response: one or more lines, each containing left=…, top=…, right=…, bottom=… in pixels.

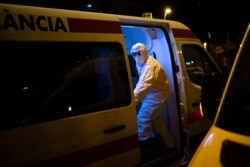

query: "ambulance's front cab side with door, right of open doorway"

left=169, top=21, right=220, bottom=137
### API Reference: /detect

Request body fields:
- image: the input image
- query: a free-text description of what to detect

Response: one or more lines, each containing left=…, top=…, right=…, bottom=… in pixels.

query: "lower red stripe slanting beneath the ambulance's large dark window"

left=32, top=134, right=139, bottom=167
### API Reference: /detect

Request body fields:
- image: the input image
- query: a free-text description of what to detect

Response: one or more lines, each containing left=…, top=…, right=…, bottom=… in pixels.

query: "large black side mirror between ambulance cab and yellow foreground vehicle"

left=201, top=74, right=225, bottom=120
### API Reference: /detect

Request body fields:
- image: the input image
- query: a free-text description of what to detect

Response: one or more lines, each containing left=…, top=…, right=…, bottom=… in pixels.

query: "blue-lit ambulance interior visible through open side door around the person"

left=122, top=26, right=183, bottom=162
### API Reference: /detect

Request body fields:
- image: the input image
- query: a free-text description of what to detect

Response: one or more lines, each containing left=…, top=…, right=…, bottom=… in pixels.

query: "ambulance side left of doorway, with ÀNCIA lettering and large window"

left=0, top=4, right=140, bottom=167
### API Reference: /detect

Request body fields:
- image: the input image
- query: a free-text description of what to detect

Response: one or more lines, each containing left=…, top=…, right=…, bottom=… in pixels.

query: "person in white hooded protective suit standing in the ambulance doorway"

left=131, top=43, right=173, bottom=148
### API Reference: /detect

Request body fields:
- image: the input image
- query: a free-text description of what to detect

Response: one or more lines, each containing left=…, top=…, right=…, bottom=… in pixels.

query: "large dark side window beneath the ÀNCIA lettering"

left=0, top=42, right=131, bottom=130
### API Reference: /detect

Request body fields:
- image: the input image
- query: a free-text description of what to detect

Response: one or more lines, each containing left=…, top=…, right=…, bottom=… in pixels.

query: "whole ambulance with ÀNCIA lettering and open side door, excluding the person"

left=0, top=3, right=221, bottom=167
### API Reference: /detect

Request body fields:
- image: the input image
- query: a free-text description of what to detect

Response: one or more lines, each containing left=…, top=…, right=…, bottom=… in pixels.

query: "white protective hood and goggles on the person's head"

left=131, top=43, right=148, bottom=65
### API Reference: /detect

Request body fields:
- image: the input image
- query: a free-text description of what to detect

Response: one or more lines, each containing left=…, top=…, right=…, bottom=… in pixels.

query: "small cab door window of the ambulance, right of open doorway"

left=182, top=44, right=218, bottom=85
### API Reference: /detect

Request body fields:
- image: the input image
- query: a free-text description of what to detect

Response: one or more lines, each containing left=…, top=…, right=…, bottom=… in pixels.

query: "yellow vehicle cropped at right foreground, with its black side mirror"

left=188, top=24, right=250, bottom=167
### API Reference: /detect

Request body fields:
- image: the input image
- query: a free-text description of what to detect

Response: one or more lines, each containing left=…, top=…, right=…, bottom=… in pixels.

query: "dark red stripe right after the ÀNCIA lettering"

left=68, top=18, right=122, bottom=34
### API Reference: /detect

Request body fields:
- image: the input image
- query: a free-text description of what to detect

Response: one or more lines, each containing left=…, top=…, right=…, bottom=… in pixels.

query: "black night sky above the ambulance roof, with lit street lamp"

left=0, top=0, right=250, bottom=40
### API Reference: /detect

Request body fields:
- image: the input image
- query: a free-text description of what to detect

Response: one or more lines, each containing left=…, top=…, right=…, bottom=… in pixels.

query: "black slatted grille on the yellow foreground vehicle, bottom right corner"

left=220, top=140, right=250, bottom=167
